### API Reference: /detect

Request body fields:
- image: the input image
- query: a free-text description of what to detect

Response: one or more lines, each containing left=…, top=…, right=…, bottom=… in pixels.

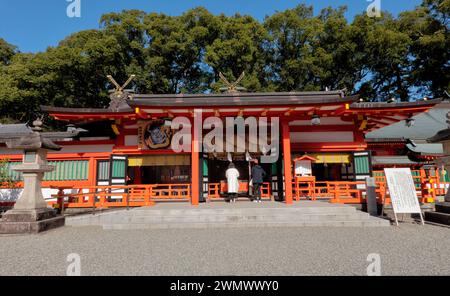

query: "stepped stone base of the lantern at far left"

left=0, top=208, right=65, bottom=234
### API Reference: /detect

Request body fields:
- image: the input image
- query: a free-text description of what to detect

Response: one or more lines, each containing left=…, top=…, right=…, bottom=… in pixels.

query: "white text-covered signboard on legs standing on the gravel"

left=384, top=168, right=423, bottom=224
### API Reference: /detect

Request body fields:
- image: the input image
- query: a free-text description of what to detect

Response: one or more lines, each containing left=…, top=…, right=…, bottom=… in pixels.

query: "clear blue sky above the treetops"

left=0, top=0, right=421, bottom=52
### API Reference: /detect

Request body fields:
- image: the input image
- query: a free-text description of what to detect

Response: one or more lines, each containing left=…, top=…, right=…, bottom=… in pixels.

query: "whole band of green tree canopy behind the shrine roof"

left=0, top=0, right=450, bottom=122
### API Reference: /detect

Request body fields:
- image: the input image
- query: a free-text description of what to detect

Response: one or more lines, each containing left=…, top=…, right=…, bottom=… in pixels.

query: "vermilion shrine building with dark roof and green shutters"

left=0, top=91, right=440, bottom=207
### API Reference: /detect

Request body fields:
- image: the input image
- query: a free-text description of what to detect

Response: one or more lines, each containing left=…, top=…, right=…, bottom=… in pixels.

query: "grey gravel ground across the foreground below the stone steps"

left=0, top=224, right=450, bottom=276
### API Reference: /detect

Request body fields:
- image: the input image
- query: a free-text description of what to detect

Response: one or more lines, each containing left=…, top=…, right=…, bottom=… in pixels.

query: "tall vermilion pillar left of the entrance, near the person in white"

left=191, top=112, right=200, bottom=206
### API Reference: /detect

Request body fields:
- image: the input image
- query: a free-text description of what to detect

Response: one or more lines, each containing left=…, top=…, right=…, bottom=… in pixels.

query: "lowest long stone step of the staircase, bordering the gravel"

left=103, top=219, right=391, bottom=230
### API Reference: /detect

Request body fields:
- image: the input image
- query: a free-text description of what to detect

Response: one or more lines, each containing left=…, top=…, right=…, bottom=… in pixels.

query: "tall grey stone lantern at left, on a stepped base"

left=0, top=120, right=84, bottom=234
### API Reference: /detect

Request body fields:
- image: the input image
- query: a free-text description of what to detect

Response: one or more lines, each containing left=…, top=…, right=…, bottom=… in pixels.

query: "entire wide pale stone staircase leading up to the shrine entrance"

left=66, top=201, right=390, bottom=230
